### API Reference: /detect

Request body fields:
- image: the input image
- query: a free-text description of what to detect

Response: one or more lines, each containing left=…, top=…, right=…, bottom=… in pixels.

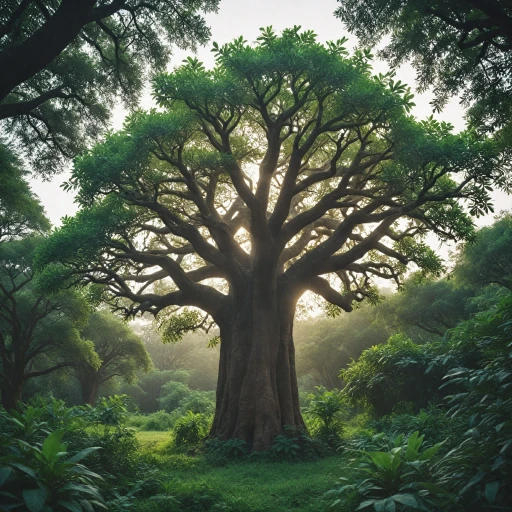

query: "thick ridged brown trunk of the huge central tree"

left=210, top=283, right=305, bottom=451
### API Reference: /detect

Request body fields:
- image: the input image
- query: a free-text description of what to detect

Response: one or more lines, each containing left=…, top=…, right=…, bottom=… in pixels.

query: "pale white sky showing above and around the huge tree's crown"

left=32, top=0, right=512, bottom=242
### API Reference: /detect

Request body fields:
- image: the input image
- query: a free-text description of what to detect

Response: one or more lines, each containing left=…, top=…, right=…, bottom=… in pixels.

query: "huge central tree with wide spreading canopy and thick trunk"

left=38, top=27, right=503, bottom=450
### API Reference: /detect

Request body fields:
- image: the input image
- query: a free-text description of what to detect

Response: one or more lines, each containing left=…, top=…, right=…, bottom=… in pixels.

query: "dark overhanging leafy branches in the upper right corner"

left=336, top=0, right=512, bottom=137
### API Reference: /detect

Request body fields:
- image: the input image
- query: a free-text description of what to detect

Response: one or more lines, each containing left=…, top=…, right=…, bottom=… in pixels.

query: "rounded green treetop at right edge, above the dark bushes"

left=455, top=213, right=512, bottom=290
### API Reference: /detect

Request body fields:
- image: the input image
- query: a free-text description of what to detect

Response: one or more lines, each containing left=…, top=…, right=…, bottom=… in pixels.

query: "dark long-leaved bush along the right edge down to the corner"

left=432, top=294, right=512, bottom=511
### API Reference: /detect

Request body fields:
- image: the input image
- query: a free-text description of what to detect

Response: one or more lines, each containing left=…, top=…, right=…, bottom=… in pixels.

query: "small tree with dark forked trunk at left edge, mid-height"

left=0, top=237, right=99, bottom=410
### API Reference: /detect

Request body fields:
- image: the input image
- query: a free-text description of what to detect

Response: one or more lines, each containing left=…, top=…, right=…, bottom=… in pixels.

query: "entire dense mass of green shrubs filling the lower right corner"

left=333, top=293, right=512, bottom=511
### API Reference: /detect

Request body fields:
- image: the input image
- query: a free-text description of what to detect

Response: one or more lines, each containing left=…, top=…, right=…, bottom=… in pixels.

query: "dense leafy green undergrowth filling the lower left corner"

left=0, top=397, right=146, bottom=512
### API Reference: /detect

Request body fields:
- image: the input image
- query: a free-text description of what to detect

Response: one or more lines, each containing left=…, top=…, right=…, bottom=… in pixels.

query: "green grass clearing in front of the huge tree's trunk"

left=133, top=432, right=346, bottom=512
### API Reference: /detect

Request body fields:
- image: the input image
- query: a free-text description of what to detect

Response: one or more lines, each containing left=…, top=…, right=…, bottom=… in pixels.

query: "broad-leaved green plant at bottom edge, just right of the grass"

left=327, top=432, right=450, bottom=512
